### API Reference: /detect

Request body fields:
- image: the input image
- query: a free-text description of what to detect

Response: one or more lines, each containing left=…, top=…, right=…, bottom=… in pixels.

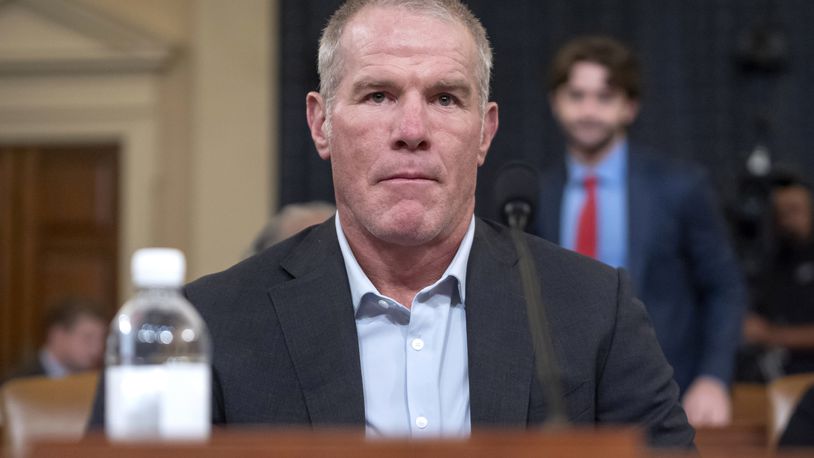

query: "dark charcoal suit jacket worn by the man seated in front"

left=93, top=218, right=694, bottom=445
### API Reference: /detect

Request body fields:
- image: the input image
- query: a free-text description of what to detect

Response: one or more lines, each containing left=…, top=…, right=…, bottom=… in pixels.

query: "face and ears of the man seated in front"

left=307, top=7, right=498, bottom=246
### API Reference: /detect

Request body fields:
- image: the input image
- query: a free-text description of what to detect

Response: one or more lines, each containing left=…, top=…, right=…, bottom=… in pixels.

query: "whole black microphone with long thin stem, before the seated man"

left=495, top=162, right=568, bottom=427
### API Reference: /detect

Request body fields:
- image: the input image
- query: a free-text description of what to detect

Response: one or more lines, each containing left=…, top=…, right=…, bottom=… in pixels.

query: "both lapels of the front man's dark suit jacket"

left=269, top=219, right=534, bottom=427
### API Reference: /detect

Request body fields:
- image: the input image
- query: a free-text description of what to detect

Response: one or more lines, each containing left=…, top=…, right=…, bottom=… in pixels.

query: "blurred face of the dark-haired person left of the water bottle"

left=49, top=316, right=107, bottom=372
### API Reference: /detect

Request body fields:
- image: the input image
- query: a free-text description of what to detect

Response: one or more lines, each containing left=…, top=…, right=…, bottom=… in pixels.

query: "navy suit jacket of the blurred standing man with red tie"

left=536, top=148, right=746, bottom=393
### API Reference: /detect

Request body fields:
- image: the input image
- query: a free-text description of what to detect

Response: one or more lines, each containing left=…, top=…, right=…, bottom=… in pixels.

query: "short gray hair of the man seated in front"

left=317, top=0, right=492, bottom=118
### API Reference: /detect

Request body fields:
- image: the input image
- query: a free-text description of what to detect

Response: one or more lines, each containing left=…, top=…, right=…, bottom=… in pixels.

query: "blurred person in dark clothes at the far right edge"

left=744, top=174, right=814, bottom=374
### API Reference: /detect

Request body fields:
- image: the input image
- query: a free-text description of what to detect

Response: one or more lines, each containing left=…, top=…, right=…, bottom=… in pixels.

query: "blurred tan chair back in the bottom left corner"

left=0, top=371, right=99, bottom=456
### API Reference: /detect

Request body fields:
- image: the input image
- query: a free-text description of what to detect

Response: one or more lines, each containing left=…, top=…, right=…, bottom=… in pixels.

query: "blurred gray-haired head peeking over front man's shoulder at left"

left=248, top=201, right=336, bottom=255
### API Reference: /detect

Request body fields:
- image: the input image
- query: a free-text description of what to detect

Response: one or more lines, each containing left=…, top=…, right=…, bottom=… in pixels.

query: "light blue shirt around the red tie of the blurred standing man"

left=560, top=140, right=629, bottom=267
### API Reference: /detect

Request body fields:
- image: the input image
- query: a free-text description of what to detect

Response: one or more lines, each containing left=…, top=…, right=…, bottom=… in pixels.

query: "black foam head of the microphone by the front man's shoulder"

left=495, top=161, right=540, bottom=229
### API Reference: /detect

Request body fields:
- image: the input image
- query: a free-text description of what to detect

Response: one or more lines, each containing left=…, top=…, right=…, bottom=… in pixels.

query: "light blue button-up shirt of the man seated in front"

left=336, top=213, right=475, bottom=437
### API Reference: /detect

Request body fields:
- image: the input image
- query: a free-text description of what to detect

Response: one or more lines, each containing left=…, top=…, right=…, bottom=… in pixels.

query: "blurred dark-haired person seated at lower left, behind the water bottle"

left=3, top=298, right=108, bottom=378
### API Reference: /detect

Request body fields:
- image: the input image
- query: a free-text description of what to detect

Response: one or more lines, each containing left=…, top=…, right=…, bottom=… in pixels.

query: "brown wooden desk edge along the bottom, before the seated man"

left=30, top=430, right=646, bottom=458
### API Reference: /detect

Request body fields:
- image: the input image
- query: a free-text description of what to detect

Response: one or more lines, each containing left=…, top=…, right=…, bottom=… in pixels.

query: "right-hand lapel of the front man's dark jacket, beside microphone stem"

left=466, top=220, right=533, bottom=427
